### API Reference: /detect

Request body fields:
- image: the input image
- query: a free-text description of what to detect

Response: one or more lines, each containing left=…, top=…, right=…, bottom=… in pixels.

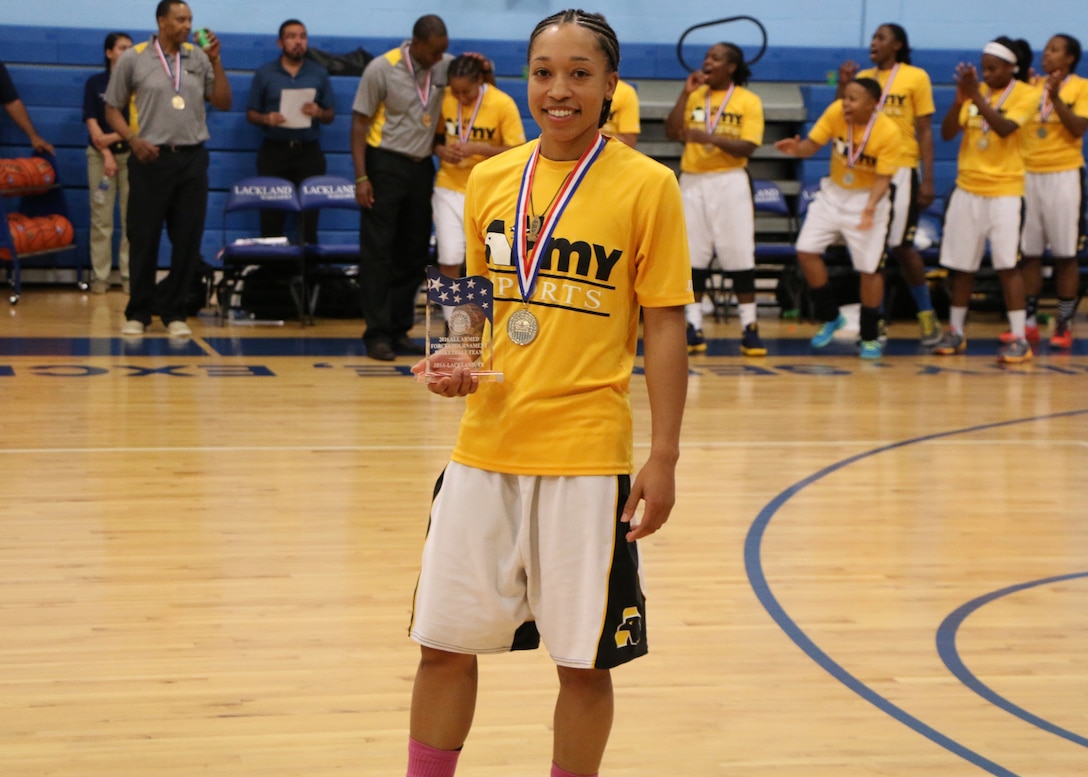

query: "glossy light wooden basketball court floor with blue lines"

left=0, top=288, right=1088, bottom=777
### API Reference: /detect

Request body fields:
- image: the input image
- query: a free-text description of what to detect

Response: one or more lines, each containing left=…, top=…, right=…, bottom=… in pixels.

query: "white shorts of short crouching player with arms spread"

left=796, top=178, right=891, bottom=273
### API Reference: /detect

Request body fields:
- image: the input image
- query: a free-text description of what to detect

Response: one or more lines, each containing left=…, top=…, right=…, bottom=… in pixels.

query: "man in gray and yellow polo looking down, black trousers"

left=351, top=14, right=453, bottom=361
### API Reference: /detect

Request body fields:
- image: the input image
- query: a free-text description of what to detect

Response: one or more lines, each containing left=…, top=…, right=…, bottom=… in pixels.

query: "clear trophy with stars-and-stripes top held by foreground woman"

left=420, top=267, right=503, bottom=383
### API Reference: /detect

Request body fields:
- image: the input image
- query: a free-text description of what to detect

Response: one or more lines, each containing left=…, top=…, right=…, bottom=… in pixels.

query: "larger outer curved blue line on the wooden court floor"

left=744, top=409, right=1088, bottom=777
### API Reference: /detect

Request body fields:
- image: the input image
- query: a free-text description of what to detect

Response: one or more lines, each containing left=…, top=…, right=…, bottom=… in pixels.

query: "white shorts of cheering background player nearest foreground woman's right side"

left=680, top=168, right=755, bottom=272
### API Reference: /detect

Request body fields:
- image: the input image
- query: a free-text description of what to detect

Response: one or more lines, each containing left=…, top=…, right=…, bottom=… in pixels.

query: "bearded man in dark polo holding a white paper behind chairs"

left=246, top=19, right=336, bottom=243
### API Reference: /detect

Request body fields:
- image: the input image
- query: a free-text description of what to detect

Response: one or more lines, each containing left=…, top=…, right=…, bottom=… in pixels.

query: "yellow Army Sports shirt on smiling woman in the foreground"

left=453, top=139, right=693, bottom=476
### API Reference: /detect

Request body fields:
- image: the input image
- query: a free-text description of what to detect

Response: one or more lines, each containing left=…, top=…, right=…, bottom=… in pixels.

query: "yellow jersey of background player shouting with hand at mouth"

left=680, top=85, right=763, bottom=173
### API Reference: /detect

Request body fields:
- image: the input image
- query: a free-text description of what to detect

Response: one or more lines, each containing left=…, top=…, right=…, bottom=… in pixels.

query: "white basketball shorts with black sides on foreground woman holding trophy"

left=410, top=461, right=646, bottom=669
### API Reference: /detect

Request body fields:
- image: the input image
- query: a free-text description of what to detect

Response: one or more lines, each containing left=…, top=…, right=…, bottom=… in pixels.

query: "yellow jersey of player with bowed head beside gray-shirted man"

left=434, top=84, right=526, bottom=192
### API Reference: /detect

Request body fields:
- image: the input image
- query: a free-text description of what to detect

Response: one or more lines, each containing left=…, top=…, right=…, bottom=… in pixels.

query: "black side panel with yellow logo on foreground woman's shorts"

left=593, top=474, right=648, bottom=669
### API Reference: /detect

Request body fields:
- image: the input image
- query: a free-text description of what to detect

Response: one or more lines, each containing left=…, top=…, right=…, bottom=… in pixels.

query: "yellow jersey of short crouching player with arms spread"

left=808, top=100, right=903, bottom=189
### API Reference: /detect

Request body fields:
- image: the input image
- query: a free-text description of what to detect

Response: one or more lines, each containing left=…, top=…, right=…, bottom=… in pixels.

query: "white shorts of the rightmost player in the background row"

left=1021, top=168, right=1084, bottom=259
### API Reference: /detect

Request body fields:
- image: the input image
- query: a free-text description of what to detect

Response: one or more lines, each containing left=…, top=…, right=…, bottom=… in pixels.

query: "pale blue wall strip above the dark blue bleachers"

left=0, top=0, right=1088, bottom=50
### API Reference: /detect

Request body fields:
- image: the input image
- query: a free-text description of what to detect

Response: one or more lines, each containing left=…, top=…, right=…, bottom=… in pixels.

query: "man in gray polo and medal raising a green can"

left=106, top=0, right=231, bottom=337
